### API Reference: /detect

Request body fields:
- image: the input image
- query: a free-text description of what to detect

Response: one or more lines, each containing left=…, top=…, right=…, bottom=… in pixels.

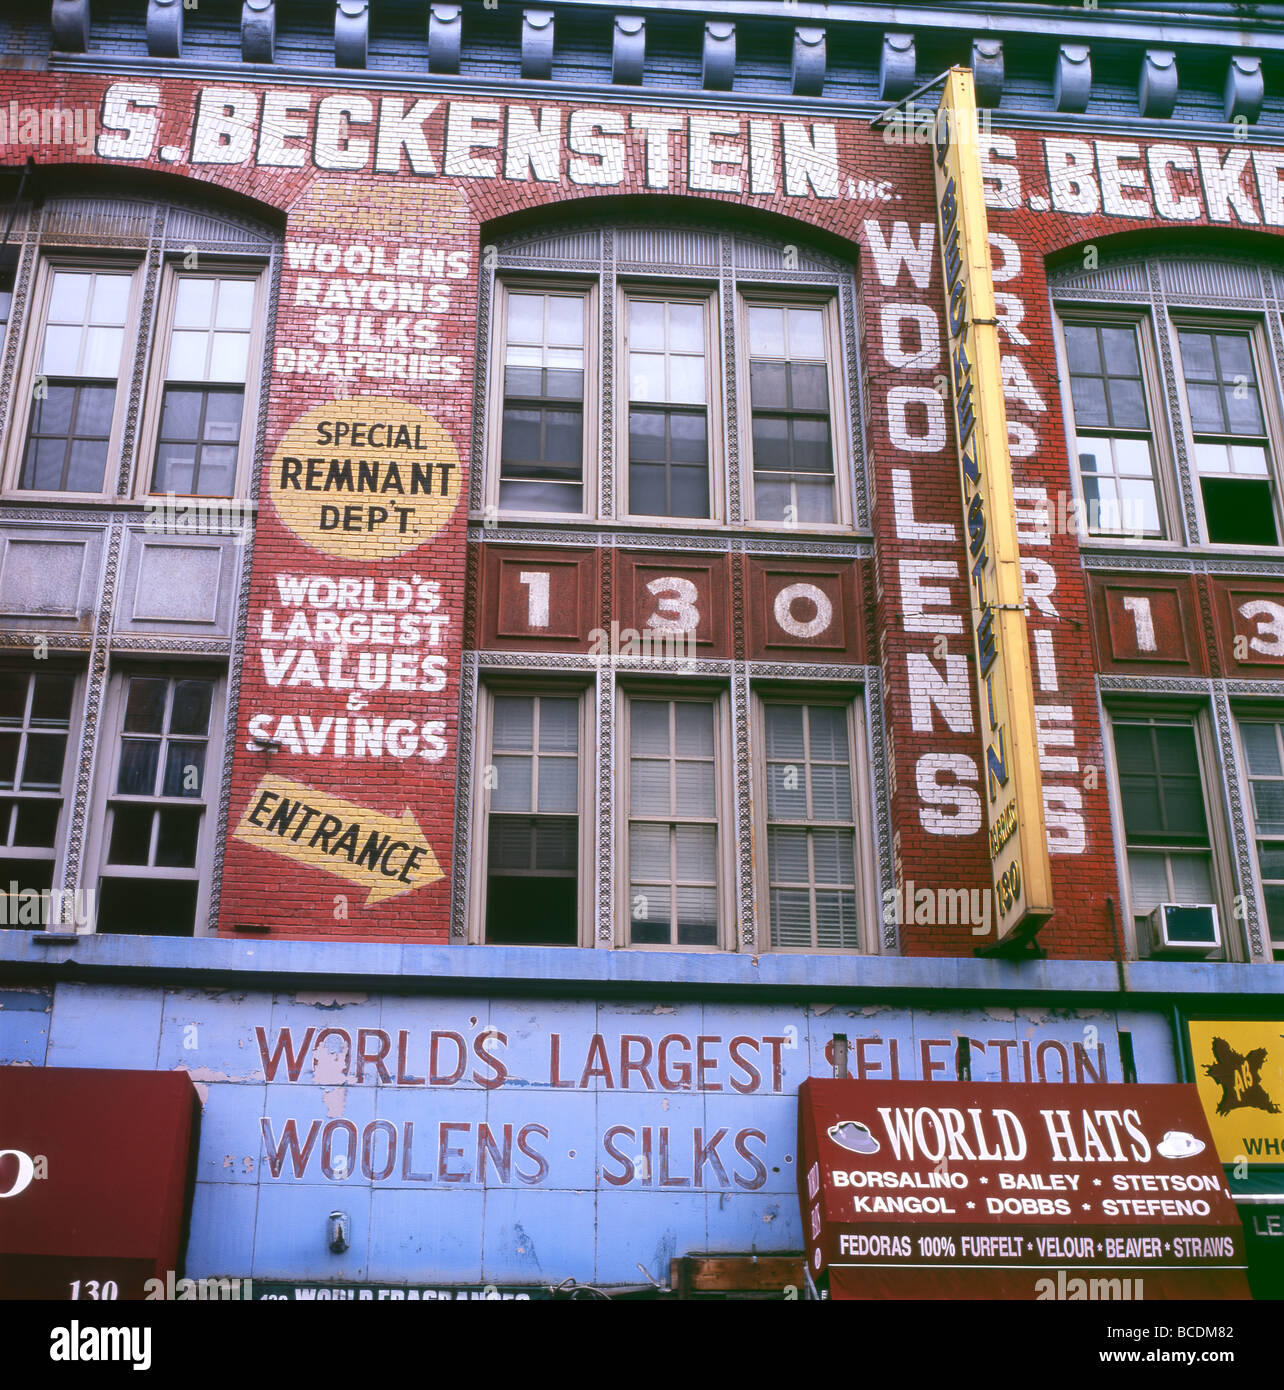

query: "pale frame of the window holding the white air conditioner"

left=1102, top=696, right=1245, bottom=960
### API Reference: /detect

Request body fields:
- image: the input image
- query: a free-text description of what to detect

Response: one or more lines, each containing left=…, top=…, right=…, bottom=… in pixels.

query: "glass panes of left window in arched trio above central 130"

left=499, top=289, right=586, bottom=513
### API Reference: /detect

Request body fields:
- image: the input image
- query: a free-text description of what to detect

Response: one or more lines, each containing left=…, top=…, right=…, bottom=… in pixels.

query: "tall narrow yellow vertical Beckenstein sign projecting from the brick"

left=934, top=76, right=1052, bottom=941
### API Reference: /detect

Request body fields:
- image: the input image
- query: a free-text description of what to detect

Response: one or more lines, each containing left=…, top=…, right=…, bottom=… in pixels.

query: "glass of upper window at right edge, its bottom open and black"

left=1177, top=328, right=1278, bottom=545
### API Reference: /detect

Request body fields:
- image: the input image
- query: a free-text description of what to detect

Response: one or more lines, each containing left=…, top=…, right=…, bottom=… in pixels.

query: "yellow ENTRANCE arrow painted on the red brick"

left=236, top=774, right=445, bottom=908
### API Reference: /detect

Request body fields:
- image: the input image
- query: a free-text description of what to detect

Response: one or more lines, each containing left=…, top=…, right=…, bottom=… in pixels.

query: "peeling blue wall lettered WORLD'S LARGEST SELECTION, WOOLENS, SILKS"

left=0, top=984, right=1176, bottom=1295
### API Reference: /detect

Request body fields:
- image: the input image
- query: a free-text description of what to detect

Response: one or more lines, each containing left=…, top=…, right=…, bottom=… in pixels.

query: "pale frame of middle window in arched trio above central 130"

left=619, top=277, right=727, bottom=530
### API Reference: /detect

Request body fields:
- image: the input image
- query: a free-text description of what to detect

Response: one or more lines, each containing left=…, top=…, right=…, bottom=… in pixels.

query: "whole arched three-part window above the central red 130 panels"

left=472, top=225, right=864, bottom=530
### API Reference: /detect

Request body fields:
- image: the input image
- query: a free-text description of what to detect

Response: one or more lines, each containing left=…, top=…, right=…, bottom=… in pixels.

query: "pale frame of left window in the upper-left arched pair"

left=3, top=249, right=149, bottom=503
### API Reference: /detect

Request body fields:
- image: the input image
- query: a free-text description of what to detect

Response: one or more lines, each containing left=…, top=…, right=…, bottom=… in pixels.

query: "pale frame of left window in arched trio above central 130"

left=482, top=272, right=602, bottom=525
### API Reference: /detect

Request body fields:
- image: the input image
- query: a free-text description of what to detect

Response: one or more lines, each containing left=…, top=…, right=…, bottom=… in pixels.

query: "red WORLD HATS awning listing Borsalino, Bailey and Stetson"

left=798, top=1077, right=1249, bottom=1301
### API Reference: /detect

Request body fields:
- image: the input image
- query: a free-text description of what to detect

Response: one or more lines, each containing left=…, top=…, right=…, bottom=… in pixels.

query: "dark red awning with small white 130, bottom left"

left=0, top=1066, right=200, bottom=1298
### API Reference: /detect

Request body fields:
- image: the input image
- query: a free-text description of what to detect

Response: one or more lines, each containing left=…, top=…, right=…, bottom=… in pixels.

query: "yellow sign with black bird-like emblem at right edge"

left=1187, top=1017, right=1284, bottom=1165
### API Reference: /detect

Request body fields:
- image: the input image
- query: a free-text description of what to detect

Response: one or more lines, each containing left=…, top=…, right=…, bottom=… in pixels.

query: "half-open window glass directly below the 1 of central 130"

left=482, top=695, right=579, bottom=945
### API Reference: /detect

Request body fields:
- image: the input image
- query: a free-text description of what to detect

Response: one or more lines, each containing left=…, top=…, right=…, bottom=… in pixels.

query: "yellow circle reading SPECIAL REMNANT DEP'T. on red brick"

left=270, top=396, right=461, bottom=560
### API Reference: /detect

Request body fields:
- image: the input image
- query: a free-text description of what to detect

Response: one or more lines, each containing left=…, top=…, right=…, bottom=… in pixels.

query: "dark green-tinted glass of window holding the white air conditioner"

left=1114, top=719, right=1217, bottom=920
